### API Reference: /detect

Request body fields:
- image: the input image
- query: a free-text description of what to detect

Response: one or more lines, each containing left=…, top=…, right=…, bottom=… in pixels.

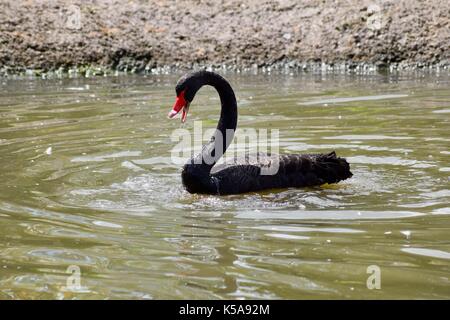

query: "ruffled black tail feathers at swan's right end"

left=315, top=151, right=353, bottom=183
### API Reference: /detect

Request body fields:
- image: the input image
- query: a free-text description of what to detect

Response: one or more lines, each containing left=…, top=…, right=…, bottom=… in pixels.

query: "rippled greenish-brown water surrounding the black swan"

left=0, top=74, right=450, bottom=299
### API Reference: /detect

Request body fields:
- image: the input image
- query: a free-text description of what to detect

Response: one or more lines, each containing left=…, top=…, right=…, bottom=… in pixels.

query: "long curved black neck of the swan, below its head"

left=182, top=71, right=237, bottom=189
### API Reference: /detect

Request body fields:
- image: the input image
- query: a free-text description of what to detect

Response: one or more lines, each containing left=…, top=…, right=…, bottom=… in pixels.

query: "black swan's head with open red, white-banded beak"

left=168, top=72, right=204, bottom=122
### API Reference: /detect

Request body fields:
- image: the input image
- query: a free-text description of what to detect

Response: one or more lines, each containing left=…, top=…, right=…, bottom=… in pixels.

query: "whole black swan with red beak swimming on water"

left=168, top=71, right=352, bottom=195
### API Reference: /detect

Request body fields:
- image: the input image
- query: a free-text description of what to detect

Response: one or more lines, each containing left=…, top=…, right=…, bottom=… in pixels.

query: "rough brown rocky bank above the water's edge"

left=0, top=0, right=450, bottom=73
